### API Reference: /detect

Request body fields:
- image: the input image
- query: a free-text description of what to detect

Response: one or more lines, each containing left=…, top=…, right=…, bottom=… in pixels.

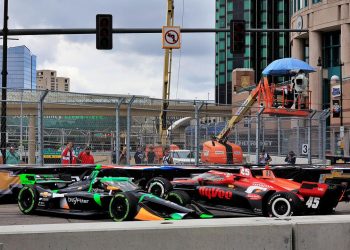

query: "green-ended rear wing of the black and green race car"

left=19, top=174, right=73, bottom=185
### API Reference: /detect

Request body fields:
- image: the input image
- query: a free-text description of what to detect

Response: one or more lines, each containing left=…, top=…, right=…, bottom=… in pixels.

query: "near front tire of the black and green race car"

left=108, top=193, right=138, bottom=222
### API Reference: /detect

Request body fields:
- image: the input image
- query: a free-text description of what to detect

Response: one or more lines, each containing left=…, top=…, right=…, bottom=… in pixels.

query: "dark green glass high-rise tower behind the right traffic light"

left=215, top=0, right=290, bottom=104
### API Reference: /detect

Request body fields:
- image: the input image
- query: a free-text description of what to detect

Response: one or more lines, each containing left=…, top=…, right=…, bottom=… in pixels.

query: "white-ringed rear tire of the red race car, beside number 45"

left=266, top=192, right=302, bottom=217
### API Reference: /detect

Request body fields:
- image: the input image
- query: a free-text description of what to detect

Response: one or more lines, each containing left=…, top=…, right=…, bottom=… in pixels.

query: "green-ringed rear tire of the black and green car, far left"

left=18, top=186, right=39, bottom=214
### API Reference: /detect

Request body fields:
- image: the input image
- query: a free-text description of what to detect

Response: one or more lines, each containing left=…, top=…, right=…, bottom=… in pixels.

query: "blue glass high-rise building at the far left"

left=0, top=45, right=36, bottom=89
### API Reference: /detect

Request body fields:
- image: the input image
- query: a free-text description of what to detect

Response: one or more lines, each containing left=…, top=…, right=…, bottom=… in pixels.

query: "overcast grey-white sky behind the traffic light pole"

left=0, top=0, right=215, bottom=99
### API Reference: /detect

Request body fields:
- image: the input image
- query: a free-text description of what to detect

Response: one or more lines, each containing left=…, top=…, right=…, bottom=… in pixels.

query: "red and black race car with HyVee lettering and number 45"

left=146, top=168, right=344, bottom=217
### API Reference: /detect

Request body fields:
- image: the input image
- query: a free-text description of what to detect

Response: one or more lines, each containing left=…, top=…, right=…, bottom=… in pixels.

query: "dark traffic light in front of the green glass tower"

left=230, top=20, right=245, bottom=54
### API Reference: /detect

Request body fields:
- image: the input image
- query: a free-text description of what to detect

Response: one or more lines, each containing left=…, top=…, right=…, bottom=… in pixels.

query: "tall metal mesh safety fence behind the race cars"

left=1, top=89, right=338, bottom=165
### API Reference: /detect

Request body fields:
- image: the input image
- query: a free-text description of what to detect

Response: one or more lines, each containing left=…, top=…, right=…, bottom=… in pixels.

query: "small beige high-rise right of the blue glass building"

left=36, top=70, right=70, bottom=92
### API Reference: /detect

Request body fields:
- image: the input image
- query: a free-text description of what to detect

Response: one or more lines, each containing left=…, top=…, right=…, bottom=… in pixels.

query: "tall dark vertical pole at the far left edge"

left=1, top=0, right=8, bottom=164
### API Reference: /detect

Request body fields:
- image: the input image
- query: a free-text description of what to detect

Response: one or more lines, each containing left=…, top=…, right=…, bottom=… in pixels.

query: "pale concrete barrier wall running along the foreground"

left=0, top=215, right=350, bottom=250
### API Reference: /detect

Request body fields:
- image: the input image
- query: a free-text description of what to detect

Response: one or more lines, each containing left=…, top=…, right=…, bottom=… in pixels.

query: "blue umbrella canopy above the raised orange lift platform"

left=262, top=58, right=316, bottom=76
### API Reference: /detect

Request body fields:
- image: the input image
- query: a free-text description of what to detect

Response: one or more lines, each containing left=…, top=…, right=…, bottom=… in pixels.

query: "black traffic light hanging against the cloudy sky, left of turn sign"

left=96, top=14, right=113, bottom=49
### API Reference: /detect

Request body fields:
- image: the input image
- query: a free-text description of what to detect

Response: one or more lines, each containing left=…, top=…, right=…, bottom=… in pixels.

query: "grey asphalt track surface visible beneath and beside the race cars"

left=0, top=202, right=350, bottom=226
